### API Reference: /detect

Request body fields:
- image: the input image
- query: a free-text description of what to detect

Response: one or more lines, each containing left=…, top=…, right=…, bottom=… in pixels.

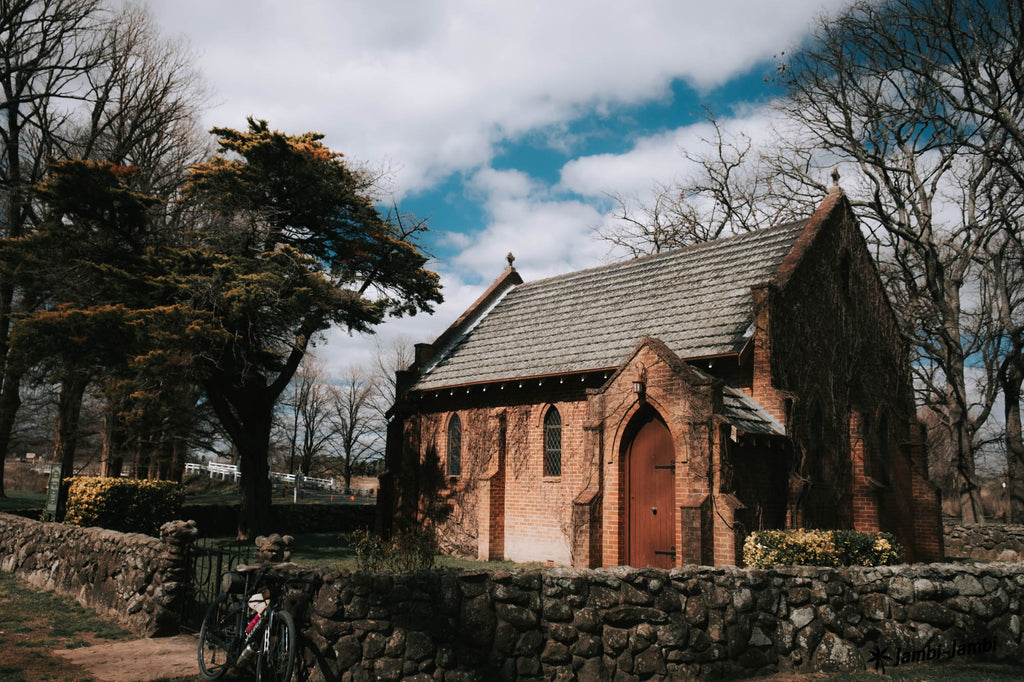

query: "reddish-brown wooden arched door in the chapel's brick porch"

left=626, top=411, right=676, bottom=568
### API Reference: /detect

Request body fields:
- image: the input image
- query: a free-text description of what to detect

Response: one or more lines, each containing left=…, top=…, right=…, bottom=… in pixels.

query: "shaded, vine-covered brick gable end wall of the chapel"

left=754, top=195, right=941, bottom=558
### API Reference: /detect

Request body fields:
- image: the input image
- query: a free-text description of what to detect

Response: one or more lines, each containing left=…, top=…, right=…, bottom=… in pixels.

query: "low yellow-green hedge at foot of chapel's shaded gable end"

left=743, top=528, right=903, bottom=568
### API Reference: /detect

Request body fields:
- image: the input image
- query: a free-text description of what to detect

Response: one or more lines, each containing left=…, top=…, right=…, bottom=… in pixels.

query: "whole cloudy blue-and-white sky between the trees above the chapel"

left=148, top=0, right=845, bottom=372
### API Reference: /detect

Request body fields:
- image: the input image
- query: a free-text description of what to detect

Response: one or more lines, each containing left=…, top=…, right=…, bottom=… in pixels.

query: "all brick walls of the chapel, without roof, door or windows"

left=382, top=194, right=942, bottom=565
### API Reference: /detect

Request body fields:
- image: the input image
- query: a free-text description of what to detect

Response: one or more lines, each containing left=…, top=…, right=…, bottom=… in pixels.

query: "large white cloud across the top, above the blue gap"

left=151, top=0, right=844, bottom=193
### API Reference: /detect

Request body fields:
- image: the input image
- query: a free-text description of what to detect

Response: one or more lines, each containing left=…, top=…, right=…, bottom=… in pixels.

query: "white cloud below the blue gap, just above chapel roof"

left=364, top=109, right=786, bottom=358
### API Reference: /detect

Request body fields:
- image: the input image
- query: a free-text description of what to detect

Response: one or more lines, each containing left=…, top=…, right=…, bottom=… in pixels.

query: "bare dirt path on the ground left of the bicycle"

left=53, top=635, right=199, bottom=682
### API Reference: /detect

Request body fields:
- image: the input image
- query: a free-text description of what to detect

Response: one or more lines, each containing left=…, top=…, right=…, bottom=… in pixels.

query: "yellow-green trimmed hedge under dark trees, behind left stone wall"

left=63, top=476, right=184, bottom=536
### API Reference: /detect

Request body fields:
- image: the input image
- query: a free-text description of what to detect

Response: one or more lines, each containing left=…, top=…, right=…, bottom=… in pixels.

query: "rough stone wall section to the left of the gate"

left=0, top=513, right=196, bottom=637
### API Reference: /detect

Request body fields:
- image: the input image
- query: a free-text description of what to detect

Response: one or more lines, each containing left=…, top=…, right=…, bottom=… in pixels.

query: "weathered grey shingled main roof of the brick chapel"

left=414, top=220, right=807, bottom=390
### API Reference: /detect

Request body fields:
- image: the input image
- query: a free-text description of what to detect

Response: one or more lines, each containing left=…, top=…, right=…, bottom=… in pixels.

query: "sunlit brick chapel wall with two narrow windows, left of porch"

left=406, top=377, right=602, bottom=564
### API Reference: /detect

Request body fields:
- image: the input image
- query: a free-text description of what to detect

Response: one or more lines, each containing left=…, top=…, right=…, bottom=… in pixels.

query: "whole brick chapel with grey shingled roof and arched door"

left=378, top=185, right=942, bottom=567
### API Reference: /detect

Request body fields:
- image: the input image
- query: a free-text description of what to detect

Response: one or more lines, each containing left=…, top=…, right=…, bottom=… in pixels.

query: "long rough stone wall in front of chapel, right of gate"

left=290, top=564, right=1024, bottom=681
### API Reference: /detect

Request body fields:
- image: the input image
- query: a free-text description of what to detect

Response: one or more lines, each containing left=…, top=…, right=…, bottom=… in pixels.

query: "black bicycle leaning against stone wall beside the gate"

left=198, top=566, right=309, bottom=682
